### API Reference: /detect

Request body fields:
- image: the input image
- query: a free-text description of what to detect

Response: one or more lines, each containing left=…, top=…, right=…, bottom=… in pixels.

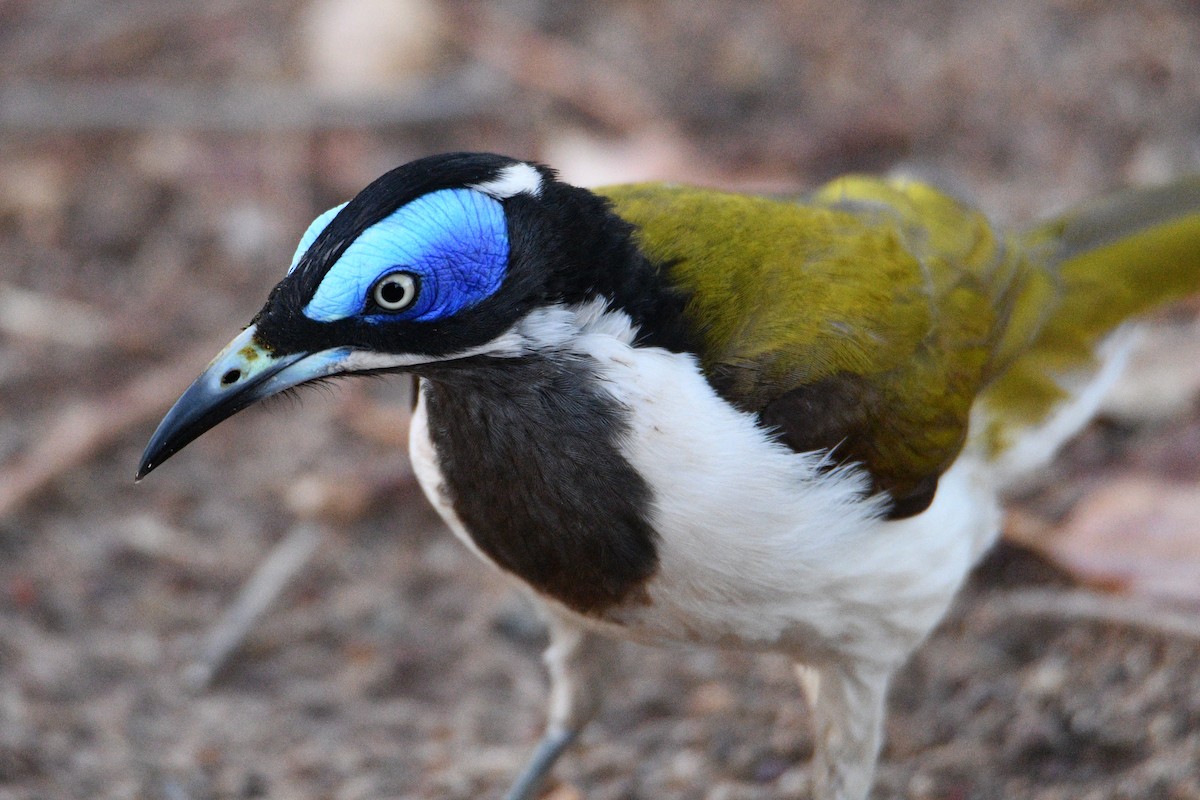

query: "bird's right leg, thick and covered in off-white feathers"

left=796, top=664, right=893, bottom=800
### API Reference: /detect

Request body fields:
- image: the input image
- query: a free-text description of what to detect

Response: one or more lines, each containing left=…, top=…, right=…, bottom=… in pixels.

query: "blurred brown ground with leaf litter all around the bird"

left=0, top=0, right=1200, bottom=800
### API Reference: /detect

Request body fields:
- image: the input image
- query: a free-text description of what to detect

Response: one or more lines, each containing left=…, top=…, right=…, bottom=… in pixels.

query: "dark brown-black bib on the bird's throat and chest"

left=422, top=356, right=658, bottom=614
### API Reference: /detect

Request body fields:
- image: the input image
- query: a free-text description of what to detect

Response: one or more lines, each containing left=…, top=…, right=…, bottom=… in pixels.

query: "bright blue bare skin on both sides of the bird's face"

left=298, top=188, right=509, bottom=323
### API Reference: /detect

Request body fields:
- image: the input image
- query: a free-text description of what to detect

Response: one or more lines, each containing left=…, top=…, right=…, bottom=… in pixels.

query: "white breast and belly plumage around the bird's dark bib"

left=412, top=314, right=1000, bottom=662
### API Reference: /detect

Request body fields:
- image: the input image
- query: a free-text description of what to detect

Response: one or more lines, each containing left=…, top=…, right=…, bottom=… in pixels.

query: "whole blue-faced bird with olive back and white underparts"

left=137, top=152, right=1200, bottom=800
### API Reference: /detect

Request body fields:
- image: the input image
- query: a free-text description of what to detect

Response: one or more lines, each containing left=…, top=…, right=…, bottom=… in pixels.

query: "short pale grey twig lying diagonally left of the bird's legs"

left=181, top=524, right=320, bottom=692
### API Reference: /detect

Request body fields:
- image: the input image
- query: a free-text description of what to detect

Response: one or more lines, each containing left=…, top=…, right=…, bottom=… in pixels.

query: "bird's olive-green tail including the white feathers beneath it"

left=974, top=178, right=1200, bottom=468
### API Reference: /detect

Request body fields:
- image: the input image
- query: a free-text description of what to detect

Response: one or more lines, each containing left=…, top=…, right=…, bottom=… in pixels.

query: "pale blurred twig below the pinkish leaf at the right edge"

left=985, top=589, right=1200, bottom=640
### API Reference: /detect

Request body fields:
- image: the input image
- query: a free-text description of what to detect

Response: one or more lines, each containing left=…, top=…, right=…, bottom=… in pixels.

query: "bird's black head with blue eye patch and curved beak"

left=138, top=154, right=667, bottom=479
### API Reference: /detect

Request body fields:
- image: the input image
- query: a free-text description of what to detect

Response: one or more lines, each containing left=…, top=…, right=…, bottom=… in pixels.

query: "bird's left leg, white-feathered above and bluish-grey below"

left=504, top=614, right=617, bottom=800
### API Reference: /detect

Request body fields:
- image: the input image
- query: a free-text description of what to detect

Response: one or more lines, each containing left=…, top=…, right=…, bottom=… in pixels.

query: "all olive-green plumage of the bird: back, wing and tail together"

left=600, top=176, right=1200, bottom=515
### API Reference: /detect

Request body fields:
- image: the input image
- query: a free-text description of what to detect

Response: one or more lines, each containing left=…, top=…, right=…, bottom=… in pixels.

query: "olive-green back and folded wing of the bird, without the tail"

left=600, top=178, right=1052, bottom=517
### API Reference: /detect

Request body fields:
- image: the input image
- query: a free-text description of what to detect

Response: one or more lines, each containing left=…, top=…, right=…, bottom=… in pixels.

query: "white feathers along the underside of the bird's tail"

left=971, top=325, right=1139, bottom=492
